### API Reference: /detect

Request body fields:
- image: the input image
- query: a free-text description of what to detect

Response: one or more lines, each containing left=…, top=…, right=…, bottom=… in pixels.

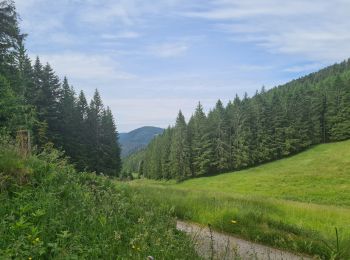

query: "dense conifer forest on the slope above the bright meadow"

left=125, top=60, right=350, bottom=179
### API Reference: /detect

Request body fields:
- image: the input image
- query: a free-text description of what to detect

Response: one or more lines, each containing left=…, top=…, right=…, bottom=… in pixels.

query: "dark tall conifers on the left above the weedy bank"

left=0, top=0, right=121, bottom=176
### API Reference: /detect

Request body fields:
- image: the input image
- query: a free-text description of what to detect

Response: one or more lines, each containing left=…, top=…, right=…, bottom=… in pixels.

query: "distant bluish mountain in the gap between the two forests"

left=119, top=126, right=164, bottom=158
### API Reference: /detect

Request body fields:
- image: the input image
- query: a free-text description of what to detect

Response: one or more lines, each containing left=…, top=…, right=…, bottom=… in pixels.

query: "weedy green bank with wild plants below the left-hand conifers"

left=0, top=141, right=198, bottom=260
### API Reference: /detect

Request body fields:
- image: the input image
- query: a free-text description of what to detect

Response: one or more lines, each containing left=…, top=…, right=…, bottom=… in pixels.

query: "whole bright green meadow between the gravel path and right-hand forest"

left=131, top=141, right=350, bottom=259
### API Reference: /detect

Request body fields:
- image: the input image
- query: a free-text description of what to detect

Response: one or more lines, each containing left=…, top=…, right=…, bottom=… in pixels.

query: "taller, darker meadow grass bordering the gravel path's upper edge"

left=133, top=185, right=350, bottom=259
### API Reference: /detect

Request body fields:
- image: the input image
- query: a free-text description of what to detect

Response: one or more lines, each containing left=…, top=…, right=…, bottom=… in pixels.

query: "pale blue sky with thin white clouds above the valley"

left=15, top=0, right=350, bottom=132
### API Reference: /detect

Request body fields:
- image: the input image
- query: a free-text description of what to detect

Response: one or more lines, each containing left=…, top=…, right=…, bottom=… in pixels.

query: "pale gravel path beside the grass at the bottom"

left=176, top=221, right=311, bottom=260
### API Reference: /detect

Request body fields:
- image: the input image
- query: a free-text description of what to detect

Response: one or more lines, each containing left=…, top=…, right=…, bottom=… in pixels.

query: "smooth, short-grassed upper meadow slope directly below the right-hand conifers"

left=138, top=140, right=350, bottom=207
